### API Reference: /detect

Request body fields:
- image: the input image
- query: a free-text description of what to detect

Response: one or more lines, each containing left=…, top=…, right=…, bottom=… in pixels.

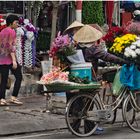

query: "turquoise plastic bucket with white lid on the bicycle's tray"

left=70, top=63, right=92, bottom=80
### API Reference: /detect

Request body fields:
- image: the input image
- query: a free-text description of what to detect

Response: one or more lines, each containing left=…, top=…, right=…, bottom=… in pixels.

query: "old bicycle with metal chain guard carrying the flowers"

left=66, top=70, right=140, bottom=137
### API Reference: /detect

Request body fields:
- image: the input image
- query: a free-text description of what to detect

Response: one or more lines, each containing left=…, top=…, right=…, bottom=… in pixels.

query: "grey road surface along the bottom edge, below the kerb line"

left=3, top=125, right=140, bottom=139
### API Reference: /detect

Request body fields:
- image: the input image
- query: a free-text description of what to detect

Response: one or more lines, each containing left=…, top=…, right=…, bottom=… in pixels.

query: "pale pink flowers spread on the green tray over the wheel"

left=40, top=67, right=69, bottom=84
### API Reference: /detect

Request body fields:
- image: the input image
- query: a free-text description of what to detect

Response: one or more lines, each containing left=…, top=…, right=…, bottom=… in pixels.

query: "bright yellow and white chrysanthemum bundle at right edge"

left=109, top=34, right=140, bottom=62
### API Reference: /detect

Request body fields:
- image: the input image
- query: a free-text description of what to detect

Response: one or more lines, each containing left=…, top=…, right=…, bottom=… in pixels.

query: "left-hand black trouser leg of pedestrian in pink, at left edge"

left=0, top=65, right=11, bottom=99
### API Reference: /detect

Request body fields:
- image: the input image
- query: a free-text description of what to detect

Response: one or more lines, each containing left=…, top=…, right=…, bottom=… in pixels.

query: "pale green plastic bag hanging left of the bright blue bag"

left=112, top=71, right=123, bottom=96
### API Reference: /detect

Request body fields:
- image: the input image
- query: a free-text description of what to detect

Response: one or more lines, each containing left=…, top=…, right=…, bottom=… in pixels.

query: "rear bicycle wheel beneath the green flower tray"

left=66, top=94, right=101, bottom=137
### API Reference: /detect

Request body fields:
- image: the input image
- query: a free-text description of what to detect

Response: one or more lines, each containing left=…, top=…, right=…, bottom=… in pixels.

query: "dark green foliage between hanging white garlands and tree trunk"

left=36, top=32, right=51, bottom=52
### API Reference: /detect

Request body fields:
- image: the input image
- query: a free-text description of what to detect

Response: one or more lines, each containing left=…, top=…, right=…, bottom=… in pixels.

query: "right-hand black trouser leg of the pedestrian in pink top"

left=10, top=65, right=22, bottom=97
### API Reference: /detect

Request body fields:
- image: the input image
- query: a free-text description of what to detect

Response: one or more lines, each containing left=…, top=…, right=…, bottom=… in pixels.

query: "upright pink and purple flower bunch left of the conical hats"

left=49, top=32, right=70, bottom=57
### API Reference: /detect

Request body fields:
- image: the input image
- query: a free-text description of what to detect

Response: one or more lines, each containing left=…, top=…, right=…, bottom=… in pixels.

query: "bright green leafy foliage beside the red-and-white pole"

left=82, top=1, right=104, bottom=26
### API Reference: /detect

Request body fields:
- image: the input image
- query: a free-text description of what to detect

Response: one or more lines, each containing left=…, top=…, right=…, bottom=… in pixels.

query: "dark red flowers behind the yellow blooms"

left=102, top=26, right=128, bottom=48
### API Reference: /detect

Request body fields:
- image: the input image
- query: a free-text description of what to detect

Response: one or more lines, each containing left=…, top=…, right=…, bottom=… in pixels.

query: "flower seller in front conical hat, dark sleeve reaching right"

left=73, top=25, right=128, bottom=72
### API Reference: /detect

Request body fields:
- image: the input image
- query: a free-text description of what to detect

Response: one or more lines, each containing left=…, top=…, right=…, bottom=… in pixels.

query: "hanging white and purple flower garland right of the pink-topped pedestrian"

left=17, top=17, right=38, bottom=68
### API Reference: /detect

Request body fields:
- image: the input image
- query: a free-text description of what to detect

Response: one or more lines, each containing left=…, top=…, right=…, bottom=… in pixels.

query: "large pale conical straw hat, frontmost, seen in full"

left=73, top=25, right=103, bottom=43
